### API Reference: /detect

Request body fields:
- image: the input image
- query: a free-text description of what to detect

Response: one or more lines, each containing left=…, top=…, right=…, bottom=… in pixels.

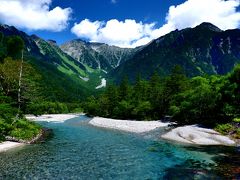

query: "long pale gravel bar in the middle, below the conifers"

left=89, top=117, right=170, bottom=133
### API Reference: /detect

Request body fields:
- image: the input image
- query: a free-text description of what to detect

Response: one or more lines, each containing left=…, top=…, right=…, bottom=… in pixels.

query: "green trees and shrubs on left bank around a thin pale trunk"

left=0, top=33, right=41, bottom=141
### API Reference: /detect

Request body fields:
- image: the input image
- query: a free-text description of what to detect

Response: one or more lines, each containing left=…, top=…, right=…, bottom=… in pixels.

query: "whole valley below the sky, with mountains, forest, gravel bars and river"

left=0, top=23, right=240, bottom=179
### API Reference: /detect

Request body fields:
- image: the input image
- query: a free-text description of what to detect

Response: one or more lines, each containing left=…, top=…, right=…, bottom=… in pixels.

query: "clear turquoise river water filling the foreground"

left=0, top=116, right=240, bottom=179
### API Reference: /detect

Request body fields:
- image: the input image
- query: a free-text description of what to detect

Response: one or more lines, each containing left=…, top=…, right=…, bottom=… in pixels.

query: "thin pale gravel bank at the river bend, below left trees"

left=26, top=114, right=83, bottom=123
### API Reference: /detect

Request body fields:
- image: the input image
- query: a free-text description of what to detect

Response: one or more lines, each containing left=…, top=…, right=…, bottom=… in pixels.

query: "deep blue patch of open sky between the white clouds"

left=29, top=0, right=184, bottom=44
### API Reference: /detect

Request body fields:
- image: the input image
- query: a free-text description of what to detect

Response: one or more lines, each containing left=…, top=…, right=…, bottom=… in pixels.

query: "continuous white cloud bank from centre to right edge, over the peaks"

left=72, top=0, right=240, bottom=47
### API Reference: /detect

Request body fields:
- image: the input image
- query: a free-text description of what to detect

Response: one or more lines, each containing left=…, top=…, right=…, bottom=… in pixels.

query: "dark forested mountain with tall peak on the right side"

left=109, top=23, right=240, bottom=81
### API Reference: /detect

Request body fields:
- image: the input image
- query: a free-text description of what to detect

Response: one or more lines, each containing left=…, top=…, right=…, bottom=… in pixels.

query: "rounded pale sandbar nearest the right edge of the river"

left=161, top=125, right=236, bottom=146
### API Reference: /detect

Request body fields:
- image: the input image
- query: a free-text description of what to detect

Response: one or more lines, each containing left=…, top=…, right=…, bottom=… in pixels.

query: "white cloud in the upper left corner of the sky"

left=0, top=0, right=72, bottom=32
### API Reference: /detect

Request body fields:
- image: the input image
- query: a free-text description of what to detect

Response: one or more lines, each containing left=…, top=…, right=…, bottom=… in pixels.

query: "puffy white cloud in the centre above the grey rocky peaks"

left=71, top=19, right=155, bottom=47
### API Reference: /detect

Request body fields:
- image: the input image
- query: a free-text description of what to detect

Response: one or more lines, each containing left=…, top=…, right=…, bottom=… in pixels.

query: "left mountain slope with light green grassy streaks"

left=0, top=25, right=101, bottom=102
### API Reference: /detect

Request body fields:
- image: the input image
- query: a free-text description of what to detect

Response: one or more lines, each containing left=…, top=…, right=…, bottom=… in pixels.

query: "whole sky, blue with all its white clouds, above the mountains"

left=0, top=0, right=240, bottom=47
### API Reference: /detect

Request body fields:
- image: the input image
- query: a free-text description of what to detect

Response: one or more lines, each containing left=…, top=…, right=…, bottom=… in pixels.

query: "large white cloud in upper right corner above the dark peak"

left=166, top=0, right=240, bottom=30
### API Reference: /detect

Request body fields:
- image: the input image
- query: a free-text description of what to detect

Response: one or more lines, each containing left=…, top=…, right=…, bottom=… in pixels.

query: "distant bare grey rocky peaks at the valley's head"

left=60, top=39, right=138, bottom=72
